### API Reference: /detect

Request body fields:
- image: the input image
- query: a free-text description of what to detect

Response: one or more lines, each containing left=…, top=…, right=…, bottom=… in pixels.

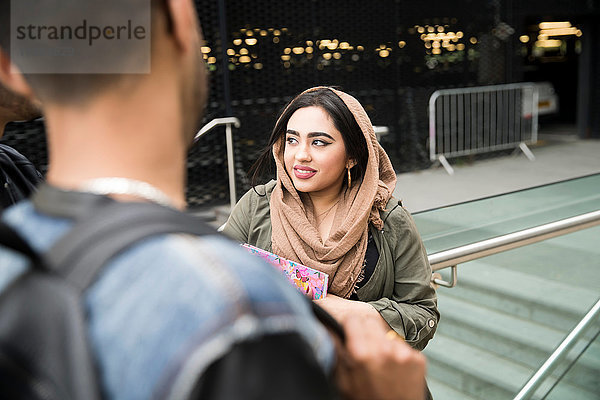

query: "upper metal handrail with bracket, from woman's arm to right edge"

left=428, top=210, right=600, bottom=287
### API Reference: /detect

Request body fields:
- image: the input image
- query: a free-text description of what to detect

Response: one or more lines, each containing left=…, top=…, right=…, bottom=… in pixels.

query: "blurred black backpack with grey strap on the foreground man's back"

left=0, top=202, right=216, bottom=400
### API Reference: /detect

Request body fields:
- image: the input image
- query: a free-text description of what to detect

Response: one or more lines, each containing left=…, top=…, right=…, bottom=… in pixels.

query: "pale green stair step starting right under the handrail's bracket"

left=452, top=260, right=598, bottom=332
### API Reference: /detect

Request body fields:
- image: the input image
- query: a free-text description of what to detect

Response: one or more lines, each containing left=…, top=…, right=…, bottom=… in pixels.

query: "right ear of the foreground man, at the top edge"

left=167, top=0, right=198, bottom=51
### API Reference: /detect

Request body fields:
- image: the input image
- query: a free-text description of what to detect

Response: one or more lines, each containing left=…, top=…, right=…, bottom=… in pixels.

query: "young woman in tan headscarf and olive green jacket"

left=224, top=87, right=439, bottom=349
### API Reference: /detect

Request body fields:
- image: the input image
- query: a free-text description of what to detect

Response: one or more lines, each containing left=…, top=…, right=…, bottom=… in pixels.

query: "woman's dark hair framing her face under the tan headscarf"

left=248, top=88, right=369, bottom=188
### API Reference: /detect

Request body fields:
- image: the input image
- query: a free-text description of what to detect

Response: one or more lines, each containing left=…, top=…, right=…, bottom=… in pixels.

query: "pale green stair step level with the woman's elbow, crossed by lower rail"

left=438, top=294, right=600, bottom=391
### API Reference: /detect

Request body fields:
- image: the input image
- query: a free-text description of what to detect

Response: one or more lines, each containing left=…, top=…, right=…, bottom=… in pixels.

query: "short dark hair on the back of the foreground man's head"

left=0, top=0, right=171, bottom=104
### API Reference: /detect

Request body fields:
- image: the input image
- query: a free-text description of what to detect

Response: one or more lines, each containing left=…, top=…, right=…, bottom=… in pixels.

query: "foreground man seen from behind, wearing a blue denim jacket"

left=0, top=0, right=425, bottom=400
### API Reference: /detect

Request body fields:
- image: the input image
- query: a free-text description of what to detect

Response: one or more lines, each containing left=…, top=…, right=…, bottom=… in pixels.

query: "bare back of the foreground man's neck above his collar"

left=45, top=83, right=186, bottom=208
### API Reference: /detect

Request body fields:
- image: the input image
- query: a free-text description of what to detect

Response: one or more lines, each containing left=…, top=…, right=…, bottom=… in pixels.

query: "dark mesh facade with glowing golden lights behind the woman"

left=3, top=0, right=600, bottom=208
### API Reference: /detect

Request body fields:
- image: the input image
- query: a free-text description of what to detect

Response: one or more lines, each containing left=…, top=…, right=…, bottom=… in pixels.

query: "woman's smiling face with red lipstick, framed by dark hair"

left=283, top=106, right=348, bottom=196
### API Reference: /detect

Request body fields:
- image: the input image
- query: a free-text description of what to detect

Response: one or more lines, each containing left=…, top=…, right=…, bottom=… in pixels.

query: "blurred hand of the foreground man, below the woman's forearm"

left=335, top=316, right=426, bottom=400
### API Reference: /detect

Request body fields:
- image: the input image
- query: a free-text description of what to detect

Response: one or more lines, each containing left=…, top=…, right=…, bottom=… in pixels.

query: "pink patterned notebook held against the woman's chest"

left=242, top=244, right=329, bottom=300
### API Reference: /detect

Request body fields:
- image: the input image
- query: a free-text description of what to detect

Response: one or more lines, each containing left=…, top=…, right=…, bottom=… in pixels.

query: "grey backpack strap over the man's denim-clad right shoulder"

left=45, top=201, right=218, bottom=291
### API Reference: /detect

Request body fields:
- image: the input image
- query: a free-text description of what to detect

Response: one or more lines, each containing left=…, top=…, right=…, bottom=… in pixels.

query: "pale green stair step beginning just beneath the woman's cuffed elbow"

left=424, top=332, right=598, bottom=400
